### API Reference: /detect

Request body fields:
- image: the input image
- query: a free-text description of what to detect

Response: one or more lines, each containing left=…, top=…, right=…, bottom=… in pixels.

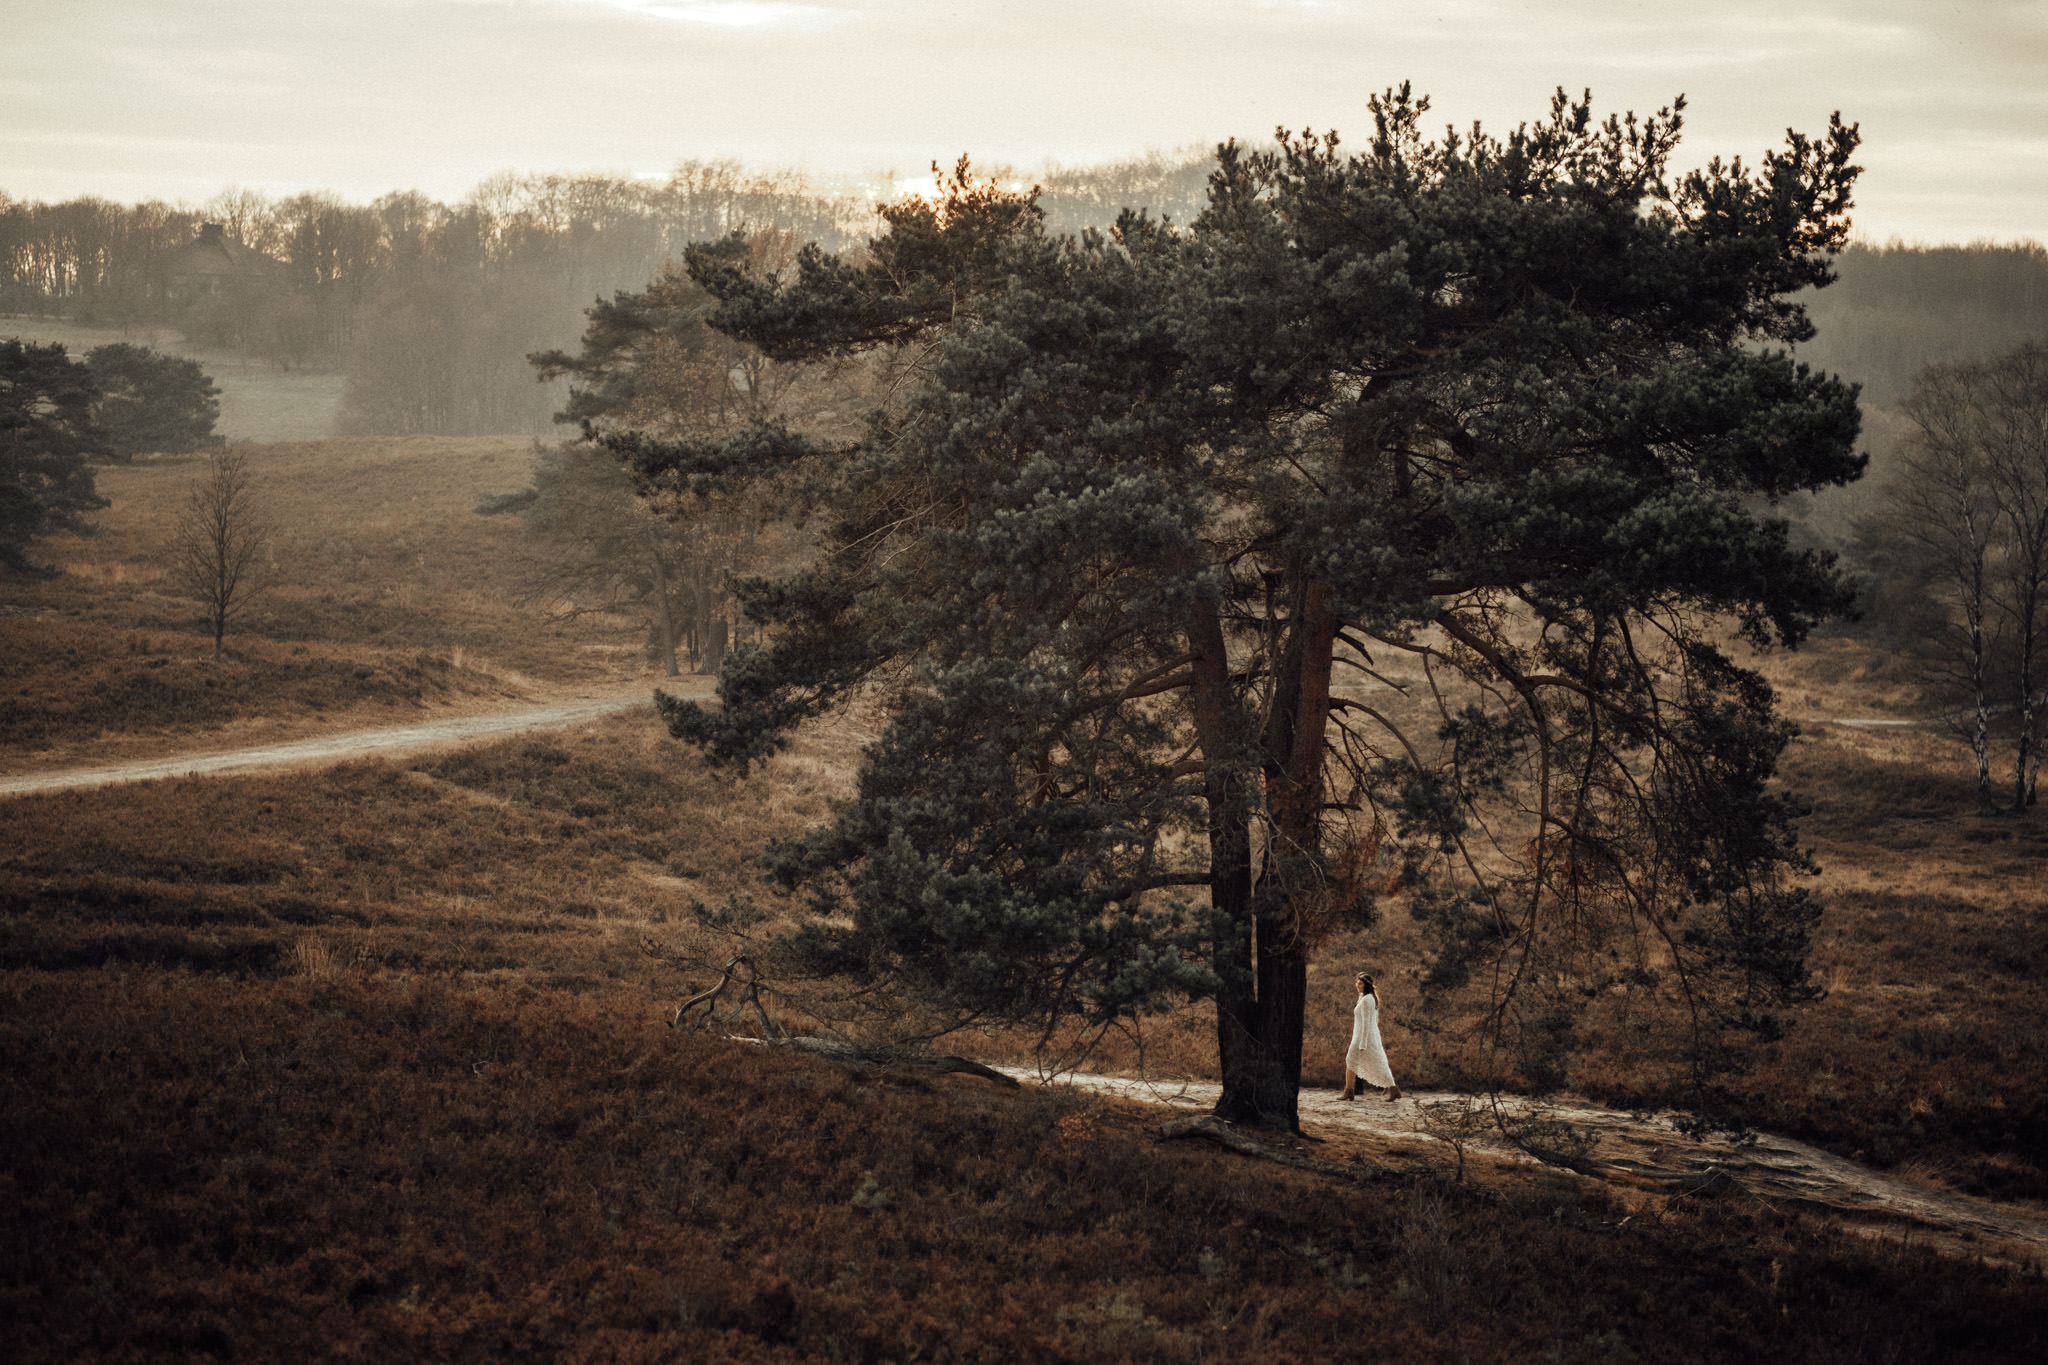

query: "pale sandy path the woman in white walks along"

left=997, top=1066, right=2048, bottom=1265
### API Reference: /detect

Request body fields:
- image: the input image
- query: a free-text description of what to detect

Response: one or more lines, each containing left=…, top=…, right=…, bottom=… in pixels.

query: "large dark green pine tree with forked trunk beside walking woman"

left=610, top=88, right=1862, bottom=1128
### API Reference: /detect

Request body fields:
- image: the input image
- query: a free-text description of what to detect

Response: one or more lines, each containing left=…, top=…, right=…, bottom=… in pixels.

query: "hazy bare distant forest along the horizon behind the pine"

left=0, top=153, right=2048, bottom=435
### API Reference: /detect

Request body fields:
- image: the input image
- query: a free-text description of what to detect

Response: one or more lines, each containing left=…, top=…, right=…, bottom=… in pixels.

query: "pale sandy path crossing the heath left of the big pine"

left=0, top=679, right=711, bottom=796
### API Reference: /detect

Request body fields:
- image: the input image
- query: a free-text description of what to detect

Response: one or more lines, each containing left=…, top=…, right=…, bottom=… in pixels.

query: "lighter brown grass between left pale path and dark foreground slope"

left=0, top=716, right=852, bottom=1011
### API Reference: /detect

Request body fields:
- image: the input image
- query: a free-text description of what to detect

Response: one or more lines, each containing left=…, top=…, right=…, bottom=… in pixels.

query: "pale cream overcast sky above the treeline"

left=0, top=0, right=2048, bottom=241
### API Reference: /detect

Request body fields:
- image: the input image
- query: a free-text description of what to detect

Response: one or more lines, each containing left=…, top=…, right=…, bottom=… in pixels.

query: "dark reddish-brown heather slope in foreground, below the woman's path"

left=0, top=966, right=2042, bottom=1363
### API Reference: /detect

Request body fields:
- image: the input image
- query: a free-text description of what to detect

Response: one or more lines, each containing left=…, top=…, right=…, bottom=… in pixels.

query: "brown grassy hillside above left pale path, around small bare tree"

left=0, top=438, right=671, bottom=763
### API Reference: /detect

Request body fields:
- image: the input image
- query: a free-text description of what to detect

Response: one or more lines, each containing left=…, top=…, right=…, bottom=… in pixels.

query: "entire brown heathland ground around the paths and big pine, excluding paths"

left=0, top=442, right=2048, bottom=1361
